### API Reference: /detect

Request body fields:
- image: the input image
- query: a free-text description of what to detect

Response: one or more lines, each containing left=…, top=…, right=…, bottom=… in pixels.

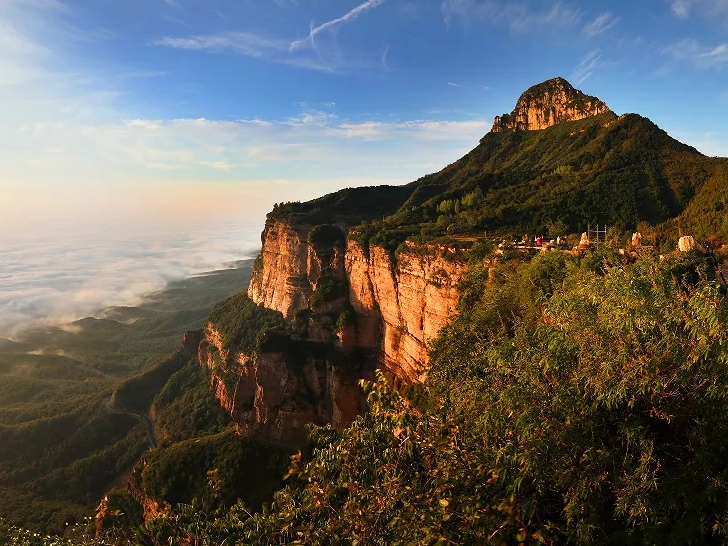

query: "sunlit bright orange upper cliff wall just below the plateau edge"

left=248, top=221, right=464, bottom=384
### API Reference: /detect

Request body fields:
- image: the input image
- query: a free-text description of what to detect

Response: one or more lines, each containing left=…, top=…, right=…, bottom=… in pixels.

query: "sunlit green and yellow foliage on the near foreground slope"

left=8, top=256, right=728, bottom=545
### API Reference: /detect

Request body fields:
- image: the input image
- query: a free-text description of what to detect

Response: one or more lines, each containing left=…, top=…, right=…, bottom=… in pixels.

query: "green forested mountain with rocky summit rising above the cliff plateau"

left=272, top=78, right=728, bottom=247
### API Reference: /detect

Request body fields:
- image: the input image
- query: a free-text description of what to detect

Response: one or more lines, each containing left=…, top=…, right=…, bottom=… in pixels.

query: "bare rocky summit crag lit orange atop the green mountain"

left=491, top=78, right=611, bottom=133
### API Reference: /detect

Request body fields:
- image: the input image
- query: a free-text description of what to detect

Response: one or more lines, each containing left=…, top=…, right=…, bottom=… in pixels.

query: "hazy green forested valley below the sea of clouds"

left=0, top=261, right=252, bottom=532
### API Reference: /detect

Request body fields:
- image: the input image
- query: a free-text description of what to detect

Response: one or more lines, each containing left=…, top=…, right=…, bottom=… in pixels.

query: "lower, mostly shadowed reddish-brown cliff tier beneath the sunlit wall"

left=198, top=323, right=364, bottom=447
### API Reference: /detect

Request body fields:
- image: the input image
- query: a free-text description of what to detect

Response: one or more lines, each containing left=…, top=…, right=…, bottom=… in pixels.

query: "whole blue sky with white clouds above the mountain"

left=0, top=0, right=728, bottom=229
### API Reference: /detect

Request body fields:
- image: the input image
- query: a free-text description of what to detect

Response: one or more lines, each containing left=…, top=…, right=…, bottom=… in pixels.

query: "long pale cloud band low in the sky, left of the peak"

left=11, top=102, right=488, bottom=191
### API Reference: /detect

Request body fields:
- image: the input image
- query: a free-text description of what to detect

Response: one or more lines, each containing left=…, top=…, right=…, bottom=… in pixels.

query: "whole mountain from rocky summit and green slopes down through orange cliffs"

left=199, top=78, right=720, bottom=444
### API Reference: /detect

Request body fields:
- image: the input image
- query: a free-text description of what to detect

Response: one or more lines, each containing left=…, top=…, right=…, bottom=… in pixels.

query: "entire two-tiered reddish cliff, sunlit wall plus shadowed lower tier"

left=191, top=218, right=463, bottom=447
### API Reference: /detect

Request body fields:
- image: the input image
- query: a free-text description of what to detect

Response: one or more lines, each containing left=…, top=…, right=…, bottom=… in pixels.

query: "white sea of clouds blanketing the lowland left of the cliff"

left=0, top=217, right=261, bottom=339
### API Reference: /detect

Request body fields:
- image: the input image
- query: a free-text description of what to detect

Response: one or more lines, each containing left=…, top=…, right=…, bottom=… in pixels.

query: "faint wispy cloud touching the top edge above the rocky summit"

left=441, top=0, right=583, bottom=33
